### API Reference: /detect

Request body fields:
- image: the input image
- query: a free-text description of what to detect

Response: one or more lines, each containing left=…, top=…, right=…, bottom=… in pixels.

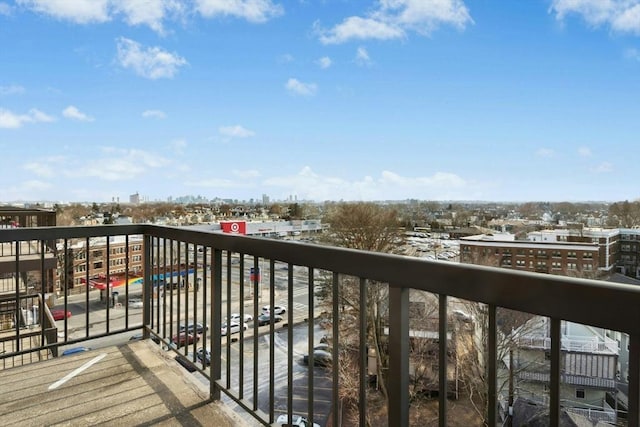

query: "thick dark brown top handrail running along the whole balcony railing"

left=0, top=224, right=640, bottom=334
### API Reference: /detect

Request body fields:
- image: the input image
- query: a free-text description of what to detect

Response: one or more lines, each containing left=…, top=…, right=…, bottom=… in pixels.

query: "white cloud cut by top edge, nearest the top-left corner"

left=17, top=0, right=111, bottom=24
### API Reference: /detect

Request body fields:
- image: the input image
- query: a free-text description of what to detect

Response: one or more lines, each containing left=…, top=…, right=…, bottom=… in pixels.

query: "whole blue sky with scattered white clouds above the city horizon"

left=0, top=0, right=640, bottom=203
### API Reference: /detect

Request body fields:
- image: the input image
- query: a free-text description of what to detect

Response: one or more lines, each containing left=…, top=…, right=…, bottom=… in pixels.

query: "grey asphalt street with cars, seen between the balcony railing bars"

left=53, top=256, right=332, bottom=425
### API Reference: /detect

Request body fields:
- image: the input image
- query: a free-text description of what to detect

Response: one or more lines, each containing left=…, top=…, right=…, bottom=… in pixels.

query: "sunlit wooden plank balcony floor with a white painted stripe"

left=0, top=341, right=246, bottom=426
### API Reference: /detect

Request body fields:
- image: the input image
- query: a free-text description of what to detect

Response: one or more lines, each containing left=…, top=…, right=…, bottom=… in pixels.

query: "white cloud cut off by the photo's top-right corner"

left=549, top=0, right=640, bottom=34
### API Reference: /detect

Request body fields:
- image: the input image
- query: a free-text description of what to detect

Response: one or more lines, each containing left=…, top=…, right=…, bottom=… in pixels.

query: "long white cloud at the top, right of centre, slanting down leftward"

left=315, top=0, right=473, bottom=44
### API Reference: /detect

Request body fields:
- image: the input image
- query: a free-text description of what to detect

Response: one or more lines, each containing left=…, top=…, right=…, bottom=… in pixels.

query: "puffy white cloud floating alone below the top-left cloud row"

left=117, top=37, right=187, bottom=79
